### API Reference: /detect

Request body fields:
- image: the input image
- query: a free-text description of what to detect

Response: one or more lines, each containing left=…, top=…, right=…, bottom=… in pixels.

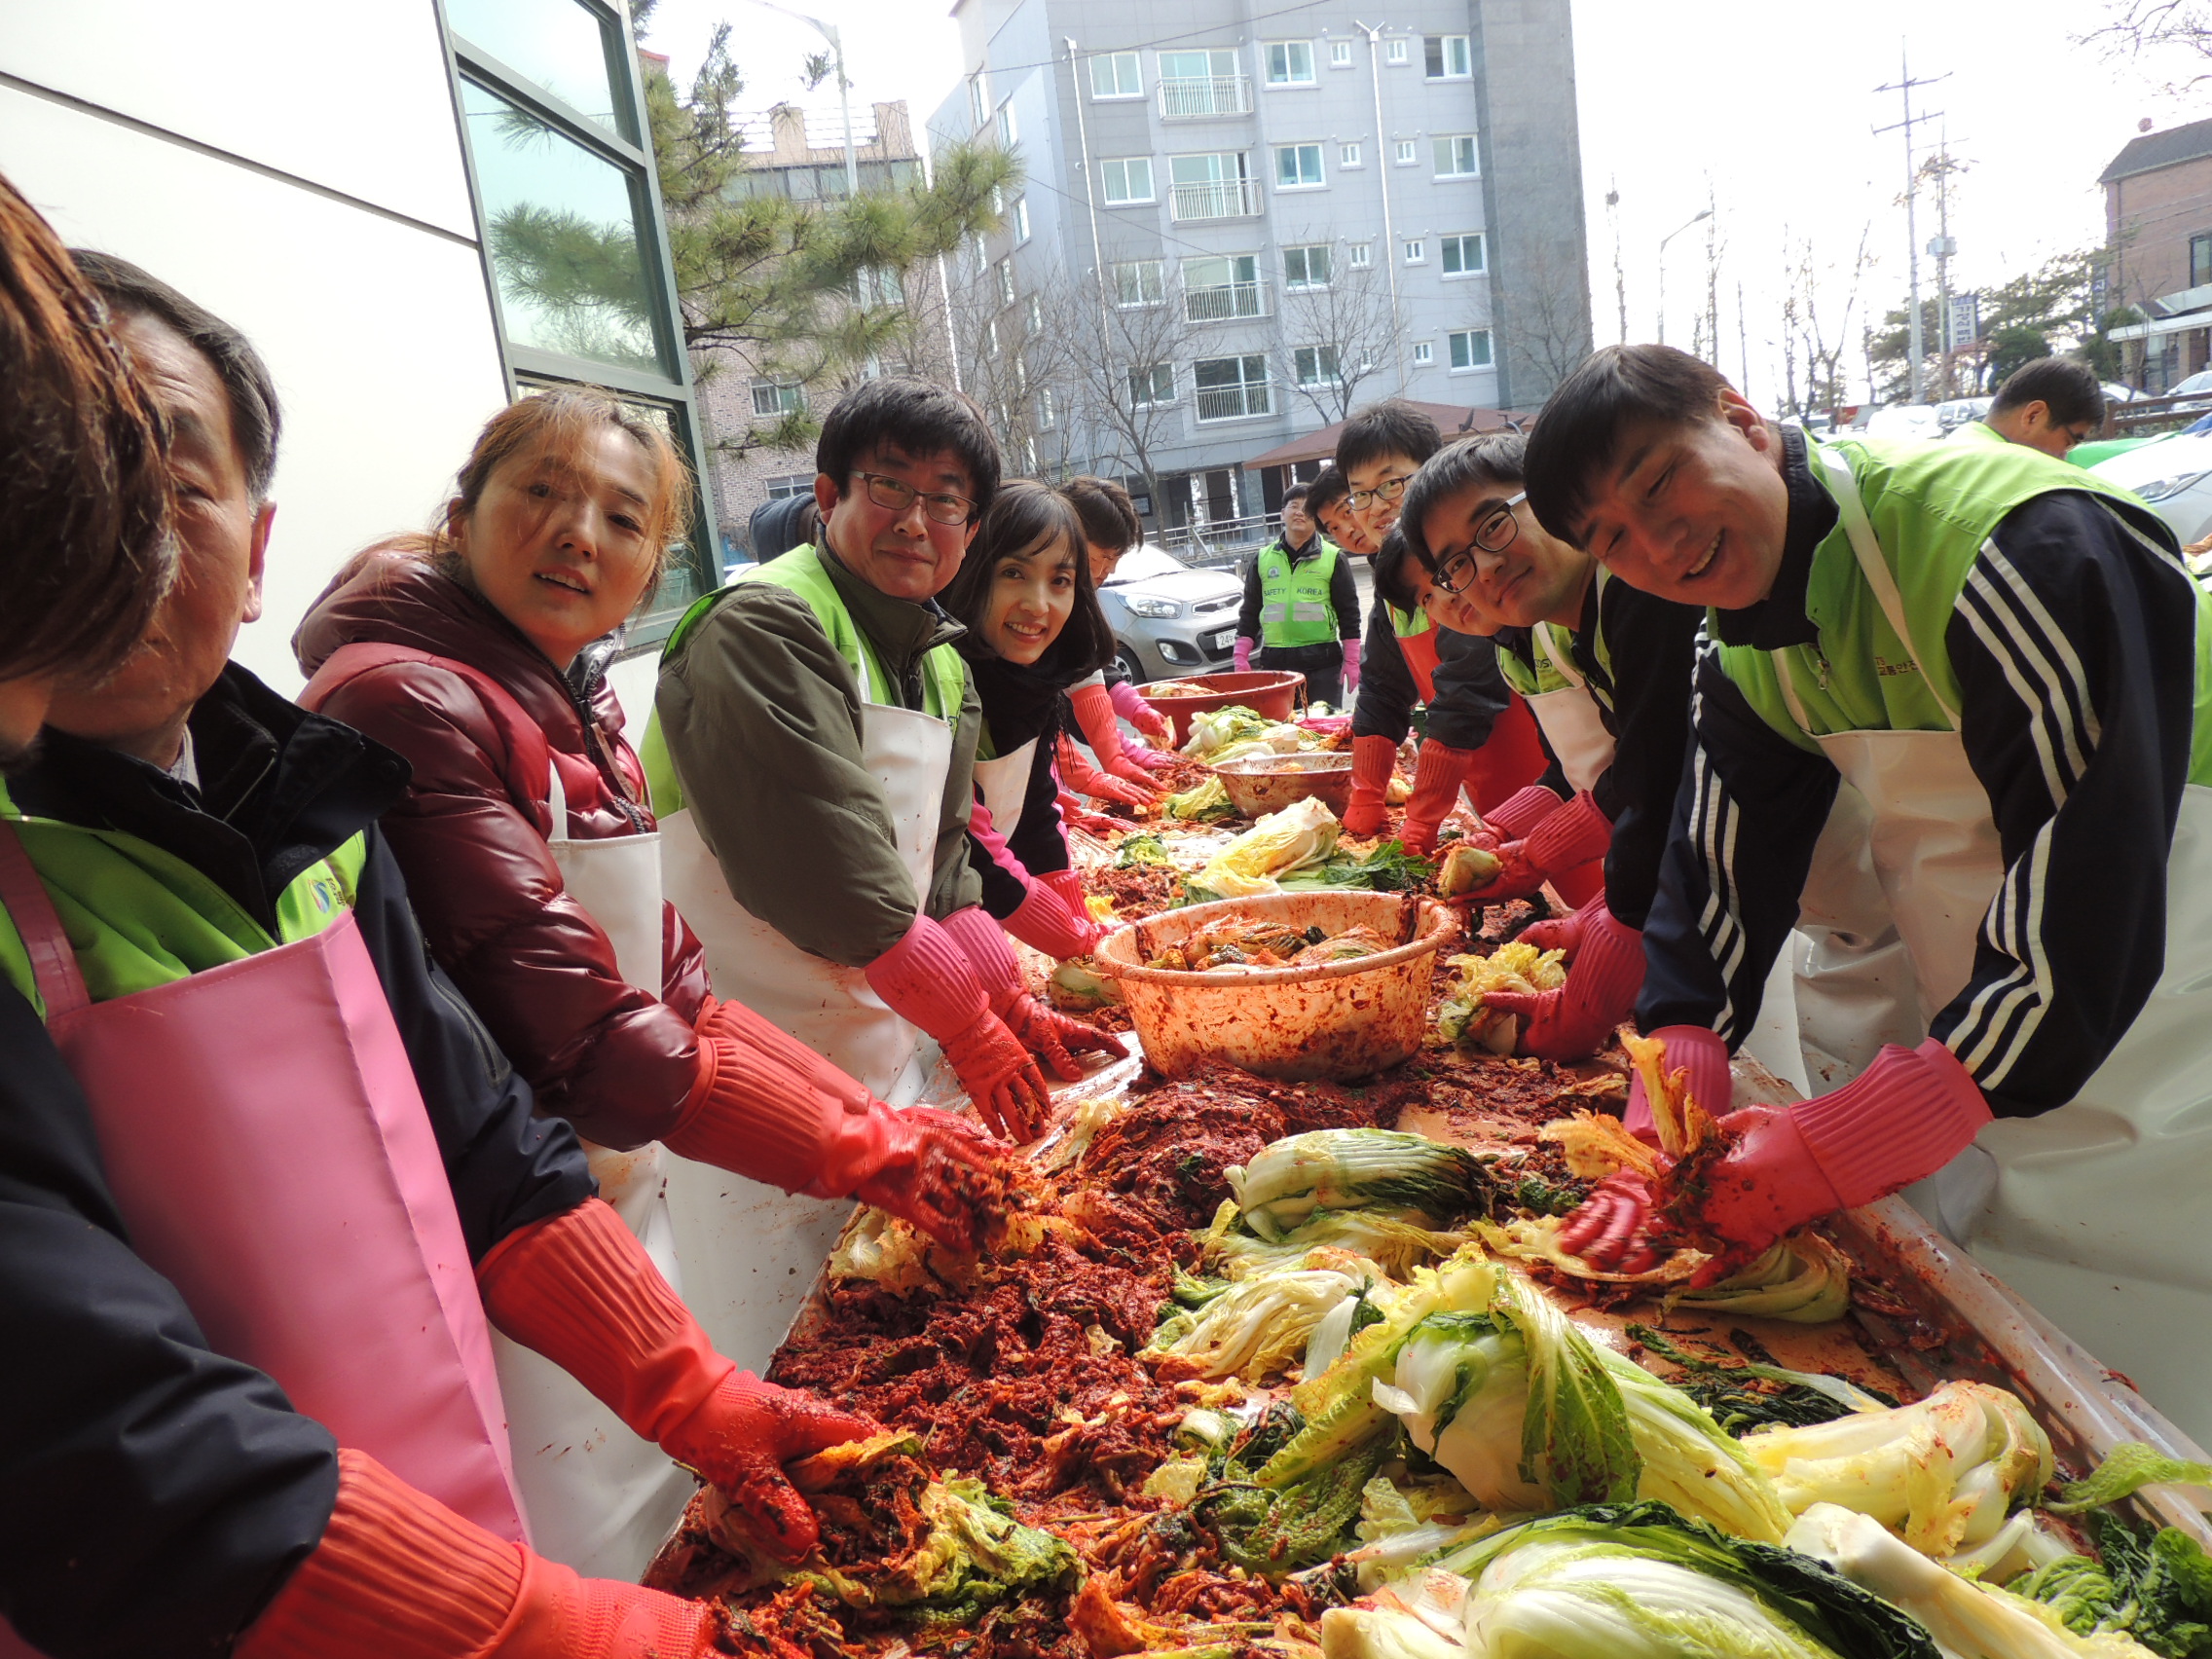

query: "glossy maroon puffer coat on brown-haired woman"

left=292, top=548, right=708, bottom=1148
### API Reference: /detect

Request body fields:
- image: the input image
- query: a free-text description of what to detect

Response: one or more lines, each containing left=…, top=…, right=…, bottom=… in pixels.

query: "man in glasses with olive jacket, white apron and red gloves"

left=645, top=379, right=1051, bottom=1150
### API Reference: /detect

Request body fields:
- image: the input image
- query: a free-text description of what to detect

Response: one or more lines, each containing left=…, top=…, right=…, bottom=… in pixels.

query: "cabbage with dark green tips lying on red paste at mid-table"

left=1228, top=1128, right=1489, bottom=1243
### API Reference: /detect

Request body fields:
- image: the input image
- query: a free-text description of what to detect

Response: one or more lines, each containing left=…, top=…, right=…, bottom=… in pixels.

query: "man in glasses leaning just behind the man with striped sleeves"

left=1396, top=431, right=1703, bottom=1059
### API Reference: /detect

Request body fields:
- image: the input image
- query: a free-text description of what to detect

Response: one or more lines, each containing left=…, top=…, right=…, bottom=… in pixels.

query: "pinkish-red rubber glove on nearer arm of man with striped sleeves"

left=1560, top=1038, right=1991, bottom=1285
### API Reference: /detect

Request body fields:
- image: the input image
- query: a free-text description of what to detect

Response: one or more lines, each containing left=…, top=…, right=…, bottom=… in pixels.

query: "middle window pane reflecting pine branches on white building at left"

left=461, top=80, right=666, bottom=374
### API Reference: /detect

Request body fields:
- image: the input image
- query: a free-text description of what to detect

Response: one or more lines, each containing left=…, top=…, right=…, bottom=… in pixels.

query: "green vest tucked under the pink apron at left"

left=0, top=786, right=369, bottom=1017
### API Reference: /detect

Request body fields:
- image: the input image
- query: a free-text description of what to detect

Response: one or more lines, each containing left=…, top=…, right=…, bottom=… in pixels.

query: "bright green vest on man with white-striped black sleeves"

left=1721, top=440, right=2212, bottom=783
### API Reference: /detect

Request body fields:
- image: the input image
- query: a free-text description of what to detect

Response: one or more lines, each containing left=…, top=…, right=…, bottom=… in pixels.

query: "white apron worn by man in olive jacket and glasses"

left=661, top=681, right=953, bottom=1372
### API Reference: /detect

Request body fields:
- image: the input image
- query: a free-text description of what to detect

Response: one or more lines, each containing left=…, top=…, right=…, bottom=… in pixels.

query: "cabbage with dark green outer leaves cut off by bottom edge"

left=1438, top=1502, right=1937, bottom=1659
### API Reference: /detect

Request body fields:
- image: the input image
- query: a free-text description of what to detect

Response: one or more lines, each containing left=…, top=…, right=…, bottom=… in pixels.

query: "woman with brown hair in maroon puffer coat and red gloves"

left=294, top=387, right=993, bottom=1577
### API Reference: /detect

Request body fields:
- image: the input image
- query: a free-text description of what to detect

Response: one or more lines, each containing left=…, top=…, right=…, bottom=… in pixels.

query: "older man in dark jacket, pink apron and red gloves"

left=0, top=257, right=871, bottom=1659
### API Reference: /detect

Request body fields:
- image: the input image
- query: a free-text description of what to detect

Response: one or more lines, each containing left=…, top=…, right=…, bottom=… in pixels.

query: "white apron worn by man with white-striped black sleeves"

left=1781, top=442, right=2212, bottom=1440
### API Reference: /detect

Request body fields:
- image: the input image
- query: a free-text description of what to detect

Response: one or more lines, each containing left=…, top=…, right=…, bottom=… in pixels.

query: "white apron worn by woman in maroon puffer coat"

left=491, top=756, right=694, bottom=1584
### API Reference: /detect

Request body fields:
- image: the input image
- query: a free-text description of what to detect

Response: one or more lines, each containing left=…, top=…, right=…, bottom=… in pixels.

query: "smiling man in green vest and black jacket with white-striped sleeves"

left=1527, top=345, right=2212, bottom=1436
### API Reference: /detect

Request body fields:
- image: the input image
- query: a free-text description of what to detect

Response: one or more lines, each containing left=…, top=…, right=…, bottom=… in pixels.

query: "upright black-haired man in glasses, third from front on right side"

left=1336, top=398, right=1548, bottom=844
